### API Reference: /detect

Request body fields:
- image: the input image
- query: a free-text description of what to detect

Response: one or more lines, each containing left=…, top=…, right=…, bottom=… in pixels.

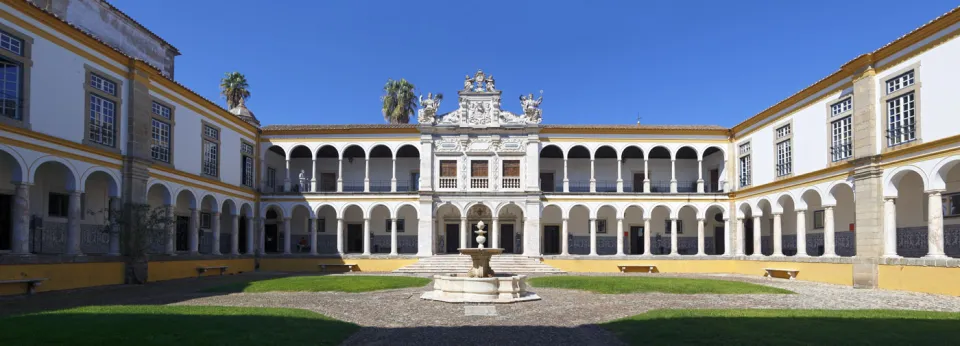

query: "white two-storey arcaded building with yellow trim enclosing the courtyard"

left=0, top=0, right=960, bottom=286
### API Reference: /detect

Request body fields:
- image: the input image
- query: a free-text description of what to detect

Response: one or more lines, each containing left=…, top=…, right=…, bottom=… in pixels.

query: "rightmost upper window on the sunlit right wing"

left=884, top=69, right=918, bottom=147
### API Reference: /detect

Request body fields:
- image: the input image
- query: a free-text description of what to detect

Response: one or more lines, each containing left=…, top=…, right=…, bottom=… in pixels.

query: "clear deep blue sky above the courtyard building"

left=109, top=0, right=957, bottom=126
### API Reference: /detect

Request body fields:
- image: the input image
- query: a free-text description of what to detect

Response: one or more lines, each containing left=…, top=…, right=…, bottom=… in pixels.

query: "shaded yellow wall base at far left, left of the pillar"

left=0, top=262, right=123, bottom=295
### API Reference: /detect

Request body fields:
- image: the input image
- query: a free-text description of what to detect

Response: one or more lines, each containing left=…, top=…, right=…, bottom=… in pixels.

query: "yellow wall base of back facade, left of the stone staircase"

left=260, top=258, right=418, bottom=272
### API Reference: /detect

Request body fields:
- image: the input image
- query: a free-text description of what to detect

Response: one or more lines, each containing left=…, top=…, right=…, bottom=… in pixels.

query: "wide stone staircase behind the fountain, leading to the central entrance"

left=393, top=255, right=564, bottom=274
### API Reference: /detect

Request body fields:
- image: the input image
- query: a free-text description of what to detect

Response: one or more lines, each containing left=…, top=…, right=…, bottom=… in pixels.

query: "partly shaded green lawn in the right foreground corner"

left=601, top=310, right=960, bottom=345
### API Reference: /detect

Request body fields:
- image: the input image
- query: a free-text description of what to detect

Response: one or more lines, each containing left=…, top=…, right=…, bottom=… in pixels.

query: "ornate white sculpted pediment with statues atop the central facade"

left=417, top=71, right=543, bottom=128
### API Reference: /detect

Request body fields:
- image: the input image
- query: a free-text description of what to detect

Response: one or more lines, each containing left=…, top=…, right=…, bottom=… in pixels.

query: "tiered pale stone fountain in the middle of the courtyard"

left=420, top=221, right=540, bottom=303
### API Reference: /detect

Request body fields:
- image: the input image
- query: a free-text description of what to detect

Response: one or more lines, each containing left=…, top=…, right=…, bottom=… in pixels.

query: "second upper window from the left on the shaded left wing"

left=87, top=73, right=117, bottom=147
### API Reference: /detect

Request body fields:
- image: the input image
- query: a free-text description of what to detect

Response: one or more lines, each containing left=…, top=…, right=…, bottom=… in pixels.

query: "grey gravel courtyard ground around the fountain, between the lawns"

left=161, top=274, right=960, bottom=345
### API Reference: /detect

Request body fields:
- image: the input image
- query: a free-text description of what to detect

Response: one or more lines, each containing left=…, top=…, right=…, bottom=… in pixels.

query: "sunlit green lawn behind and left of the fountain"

left=207, top=275, right=430, bottom=293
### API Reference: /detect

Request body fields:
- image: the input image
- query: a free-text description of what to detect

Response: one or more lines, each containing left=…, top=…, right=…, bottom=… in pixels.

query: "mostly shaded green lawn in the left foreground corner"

left=0, top=305, right=360, bottom=346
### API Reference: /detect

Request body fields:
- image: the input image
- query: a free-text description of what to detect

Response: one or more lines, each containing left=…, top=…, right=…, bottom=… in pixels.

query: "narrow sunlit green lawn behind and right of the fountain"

left=529, top=276, right=793, bottom=294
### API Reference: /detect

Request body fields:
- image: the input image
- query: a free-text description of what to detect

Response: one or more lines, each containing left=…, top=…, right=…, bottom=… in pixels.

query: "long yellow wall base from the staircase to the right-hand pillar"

left=543, top=259, right=853, bottom=286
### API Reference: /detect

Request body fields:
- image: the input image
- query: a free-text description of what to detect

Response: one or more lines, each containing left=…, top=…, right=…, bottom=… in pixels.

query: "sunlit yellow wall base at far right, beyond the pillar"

left=879, top=265, right=960, bottom=296
